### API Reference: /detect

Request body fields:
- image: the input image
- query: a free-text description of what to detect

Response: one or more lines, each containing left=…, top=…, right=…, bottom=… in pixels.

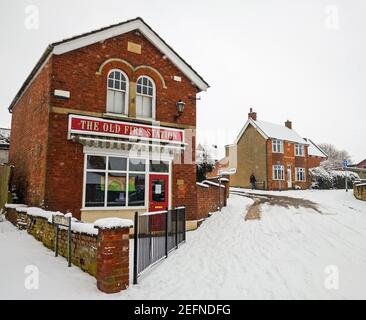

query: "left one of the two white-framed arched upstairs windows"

left=107, top=70, right=128, bottom=115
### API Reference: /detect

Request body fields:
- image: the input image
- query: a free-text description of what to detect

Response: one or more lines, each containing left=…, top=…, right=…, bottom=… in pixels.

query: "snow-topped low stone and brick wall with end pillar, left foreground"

left=5, top=208, right=129, bottom=293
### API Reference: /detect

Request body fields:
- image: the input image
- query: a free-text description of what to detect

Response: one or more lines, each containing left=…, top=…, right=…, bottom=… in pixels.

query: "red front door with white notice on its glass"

left=149, top=174, right=169, bottom=212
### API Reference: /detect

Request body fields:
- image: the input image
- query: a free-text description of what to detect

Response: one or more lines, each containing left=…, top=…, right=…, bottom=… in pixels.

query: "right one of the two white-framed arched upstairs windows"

left=136, top=76, right=155, bottom=119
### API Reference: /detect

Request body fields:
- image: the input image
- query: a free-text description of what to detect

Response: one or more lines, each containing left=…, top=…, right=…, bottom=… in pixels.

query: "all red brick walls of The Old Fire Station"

left=10, top=28, right=202, bottom=219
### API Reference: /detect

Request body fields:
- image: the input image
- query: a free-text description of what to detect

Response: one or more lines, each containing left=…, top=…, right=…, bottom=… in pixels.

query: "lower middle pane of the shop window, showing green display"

left=103, top=173, right=126, bottom=207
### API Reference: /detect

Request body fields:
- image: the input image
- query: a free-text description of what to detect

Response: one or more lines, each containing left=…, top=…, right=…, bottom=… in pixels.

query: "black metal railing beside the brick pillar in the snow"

left=133, top=207, right=186, bottom=284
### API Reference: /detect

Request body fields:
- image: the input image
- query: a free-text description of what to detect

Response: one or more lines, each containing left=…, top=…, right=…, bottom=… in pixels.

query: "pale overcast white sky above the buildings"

left=0, top=0, right=366, bottom=161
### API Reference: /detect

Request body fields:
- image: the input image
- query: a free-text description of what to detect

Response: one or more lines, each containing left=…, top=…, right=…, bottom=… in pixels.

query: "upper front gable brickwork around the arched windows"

left=51, top=32, right=197, bottom=126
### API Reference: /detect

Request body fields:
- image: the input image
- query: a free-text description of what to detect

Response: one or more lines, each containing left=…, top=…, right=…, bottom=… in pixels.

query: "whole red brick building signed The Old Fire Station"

left=9, top=18, right=208, bottom=221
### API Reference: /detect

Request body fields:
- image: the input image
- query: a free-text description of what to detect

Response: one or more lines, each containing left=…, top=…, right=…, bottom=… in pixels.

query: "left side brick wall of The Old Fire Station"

left=9, top=60, right=52, bottom=206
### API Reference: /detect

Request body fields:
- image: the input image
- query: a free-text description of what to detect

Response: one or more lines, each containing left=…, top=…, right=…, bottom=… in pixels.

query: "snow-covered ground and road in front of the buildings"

left=0, top=190, right=366, bottom=299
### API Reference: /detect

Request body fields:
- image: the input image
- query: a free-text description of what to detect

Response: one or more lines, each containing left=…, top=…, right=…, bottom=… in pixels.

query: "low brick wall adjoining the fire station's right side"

left=197, top=180, right=229, bottom=219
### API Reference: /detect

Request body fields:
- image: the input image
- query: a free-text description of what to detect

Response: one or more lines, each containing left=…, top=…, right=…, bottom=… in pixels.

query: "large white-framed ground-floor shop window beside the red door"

left=84, top=155, right=147, bottom=208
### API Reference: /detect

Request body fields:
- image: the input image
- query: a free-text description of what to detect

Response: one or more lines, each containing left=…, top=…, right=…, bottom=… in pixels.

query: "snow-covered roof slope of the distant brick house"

left=251, top=120, right=307, bottom=144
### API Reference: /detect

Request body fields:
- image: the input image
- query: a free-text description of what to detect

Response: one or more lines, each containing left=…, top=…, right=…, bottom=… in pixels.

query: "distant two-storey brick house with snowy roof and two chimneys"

left=226, top=109, right=326, bottom=190
